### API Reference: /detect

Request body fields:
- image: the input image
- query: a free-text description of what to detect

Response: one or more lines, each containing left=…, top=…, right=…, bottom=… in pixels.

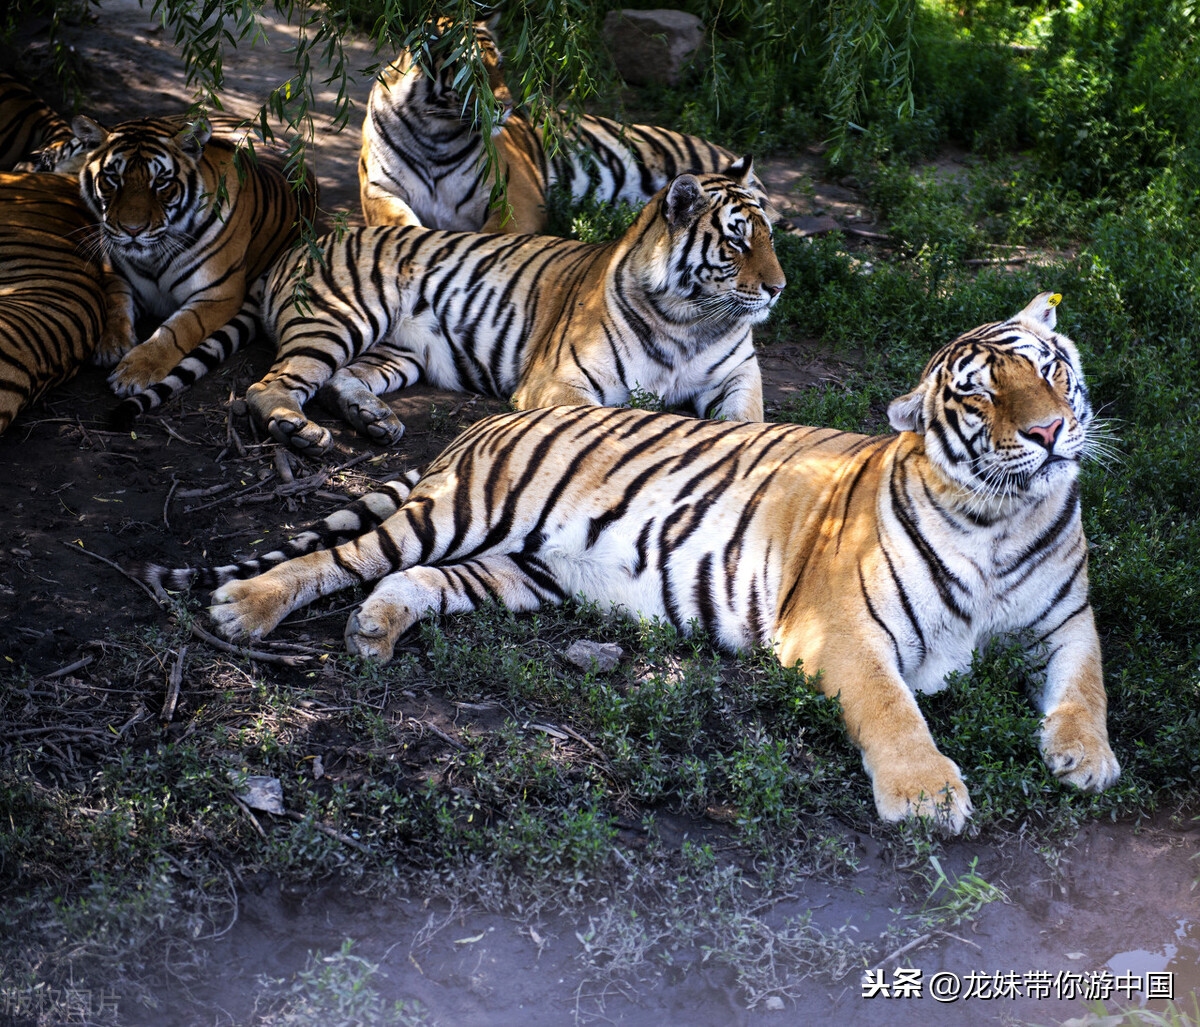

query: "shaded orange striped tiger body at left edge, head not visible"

left=0, top=172, right=131, bottom=433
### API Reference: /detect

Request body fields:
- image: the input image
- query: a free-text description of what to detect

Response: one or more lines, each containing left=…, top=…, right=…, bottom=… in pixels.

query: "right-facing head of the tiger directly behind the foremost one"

left=632, top=157, right=787, bottom=331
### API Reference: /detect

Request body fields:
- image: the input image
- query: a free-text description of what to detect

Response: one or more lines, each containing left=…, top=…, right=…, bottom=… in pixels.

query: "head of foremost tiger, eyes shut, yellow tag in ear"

left=888, top=293, right=1096, bottom=509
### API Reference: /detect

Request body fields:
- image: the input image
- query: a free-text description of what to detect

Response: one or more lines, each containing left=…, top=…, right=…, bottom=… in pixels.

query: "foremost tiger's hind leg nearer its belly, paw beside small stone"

left=346, top=554, right=566, bottom=662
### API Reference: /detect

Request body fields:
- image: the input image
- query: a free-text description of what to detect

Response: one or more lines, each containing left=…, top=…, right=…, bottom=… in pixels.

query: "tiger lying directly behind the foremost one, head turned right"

left=114, top=158, right=786, bottom=454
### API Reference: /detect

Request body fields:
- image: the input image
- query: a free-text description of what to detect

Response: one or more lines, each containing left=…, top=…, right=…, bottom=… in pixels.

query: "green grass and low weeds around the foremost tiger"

left=0, top=4, right=1200, bottom=1025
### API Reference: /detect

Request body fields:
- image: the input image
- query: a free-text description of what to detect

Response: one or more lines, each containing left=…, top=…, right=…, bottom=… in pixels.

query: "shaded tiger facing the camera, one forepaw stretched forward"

left=72, top=115, right=317, bottom=396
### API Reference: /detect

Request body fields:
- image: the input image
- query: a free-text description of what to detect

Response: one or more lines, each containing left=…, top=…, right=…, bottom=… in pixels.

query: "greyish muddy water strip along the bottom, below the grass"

left=119, top=818, right=1200, bottom=1027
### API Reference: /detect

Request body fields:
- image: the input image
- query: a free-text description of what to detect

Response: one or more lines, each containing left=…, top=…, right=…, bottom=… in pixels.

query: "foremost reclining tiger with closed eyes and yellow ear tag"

left=142, top=293, right=1120, bottom=831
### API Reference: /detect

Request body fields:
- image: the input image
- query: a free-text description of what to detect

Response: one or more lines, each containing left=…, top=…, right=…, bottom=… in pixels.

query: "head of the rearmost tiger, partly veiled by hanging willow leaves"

left=402, top=14, right=512, bottom=131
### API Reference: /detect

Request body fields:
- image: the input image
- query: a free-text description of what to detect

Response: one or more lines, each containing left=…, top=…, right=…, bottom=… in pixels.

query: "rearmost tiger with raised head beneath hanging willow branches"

left=359, top=18, right=766, bottom=234
